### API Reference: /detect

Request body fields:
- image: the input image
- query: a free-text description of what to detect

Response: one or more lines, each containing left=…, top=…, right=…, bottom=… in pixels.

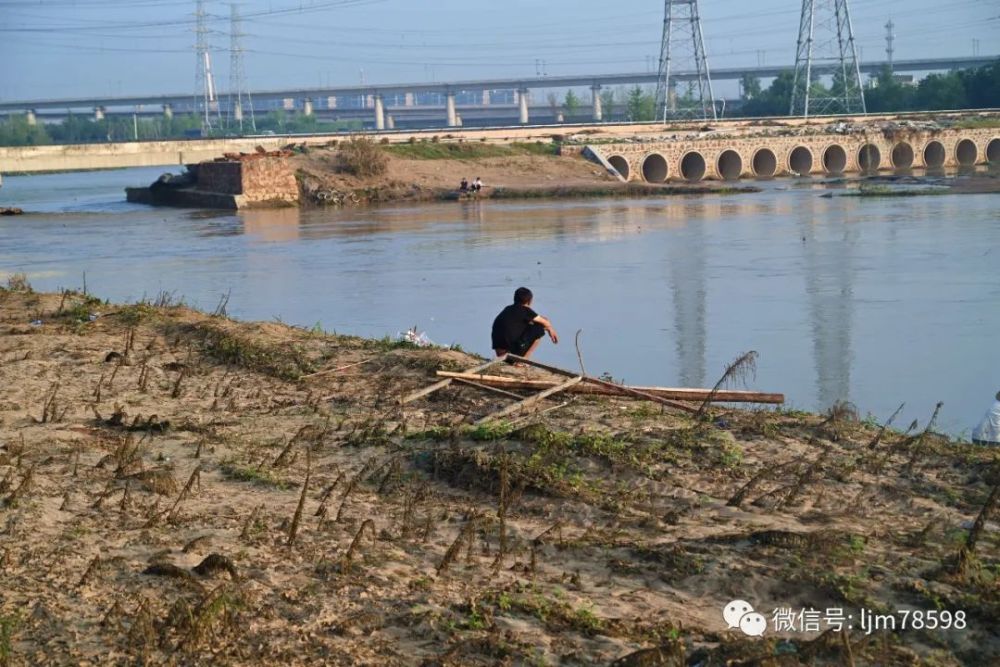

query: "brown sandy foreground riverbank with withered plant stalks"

left=0, top=284, right=1000, bottom=665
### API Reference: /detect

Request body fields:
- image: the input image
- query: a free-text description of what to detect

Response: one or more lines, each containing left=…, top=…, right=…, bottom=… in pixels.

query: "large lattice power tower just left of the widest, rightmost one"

left=656, top=0, right=716, bottom=120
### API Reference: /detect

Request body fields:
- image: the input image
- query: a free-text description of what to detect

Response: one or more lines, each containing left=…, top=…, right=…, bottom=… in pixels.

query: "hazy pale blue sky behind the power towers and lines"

left=0, top=0, right=1000, bottom=100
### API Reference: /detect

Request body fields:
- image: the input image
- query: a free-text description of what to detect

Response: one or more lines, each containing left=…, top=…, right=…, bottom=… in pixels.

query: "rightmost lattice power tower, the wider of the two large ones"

left=790, top=0, right=866, bottom=118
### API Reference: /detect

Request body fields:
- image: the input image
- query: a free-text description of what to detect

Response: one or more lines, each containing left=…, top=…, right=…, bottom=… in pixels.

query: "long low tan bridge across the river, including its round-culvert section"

left=0, top=112, right=1000, bottom=177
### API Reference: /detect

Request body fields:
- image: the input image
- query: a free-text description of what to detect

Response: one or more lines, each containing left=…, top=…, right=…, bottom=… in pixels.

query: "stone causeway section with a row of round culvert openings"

left=594, top=128, right=1000, bottom=183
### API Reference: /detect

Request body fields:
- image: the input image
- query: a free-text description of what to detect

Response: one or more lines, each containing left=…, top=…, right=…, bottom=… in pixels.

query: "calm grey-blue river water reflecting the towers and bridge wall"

left=0, top=170, right=1000, bottom=433
